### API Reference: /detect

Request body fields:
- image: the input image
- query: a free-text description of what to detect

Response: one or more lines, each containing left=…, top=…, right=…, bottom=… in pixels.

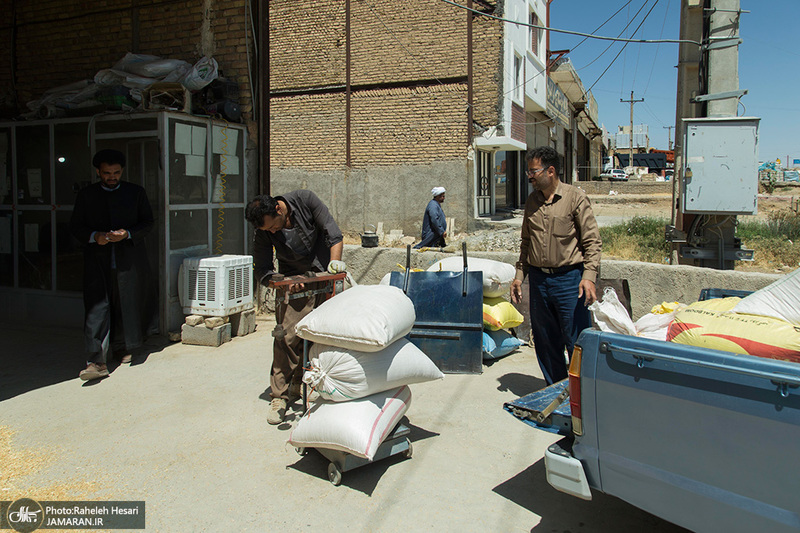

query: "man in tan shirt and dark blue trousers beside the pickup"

left=511, top=146, right=601, bottom=385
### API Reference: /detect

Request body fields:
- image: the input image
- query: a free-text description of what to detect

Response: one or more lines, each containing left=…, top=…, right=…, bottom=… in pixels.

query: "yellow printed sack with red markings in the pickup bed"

left=667, top=298, right=800, bottom=363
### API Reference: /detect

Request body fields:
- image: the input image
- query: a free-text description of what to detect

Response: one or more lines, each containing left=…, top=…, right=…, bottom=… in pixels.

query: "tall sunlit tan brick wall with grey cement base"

left=270, top=0, right=503, bottom=235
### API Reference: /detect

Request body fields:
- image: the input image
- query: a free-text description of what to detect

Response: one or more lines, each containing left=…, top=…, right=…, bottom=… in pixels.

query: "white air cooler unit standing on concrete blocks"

left=179, top=255, right=253, bottom=316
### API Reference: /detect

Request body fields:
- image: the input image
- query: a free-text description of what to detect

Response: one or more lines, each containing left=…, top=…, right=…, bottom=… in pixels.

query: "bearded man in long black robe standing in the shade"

left=70, top=150, right=153, bottom=381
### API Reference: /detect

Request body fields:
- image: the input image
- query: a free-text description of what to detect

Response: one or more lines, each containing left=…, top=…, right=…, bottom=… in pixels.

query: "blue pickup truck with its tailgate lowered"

left=505, top=302, right=800, bottom=533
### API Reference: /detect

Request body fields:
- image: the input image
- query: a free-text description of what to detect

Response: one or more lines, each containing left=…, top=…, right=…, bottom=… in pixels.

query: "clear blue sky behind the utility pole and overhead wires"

left=550, top=0, right=800, bottom=166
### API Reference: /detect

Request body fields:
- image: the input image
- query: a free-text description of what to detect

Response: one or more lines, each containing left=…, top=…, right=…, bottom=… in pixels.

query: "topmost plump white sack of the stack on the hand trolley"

left=297, top=285, right=417, bottom=352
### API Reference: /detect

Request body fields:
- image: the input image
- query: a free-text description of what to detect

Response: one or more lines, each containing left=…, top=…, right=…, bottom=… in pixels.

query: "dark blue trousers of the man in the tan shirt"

left=528, top=265, right=592, bottom=385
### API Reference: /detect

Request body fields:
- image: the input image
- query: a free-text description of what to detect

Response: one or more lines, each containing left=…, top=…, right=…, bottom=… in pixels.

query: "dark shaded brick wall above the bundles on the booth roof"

left=0, top=0, right=255, bottom=119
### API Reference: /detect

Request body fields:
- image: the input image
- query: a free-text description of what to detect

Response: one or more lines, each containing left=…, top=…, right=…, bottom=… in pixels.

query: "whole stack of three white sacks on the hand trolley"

left=289, top=285, right=444, bottom=461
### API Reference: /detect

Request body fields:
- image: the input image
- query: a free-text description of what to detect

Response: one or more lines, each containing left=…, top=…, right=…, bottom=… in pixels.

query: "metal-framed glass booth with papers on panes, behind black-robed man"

left=0, top=111, right=250, bottom=333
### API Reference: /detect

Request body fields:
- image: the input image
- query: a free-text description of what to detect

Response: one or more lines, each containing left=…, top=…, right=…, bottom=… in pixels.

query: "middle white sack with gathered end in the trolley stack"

left=303, top=339, right=444, bottom=402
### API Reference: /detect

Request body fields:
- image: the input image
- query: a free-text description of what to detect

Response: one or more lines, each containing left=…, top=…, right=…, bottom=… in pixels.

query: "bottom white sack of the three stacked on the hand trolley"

left=289, top=384, right=411, bottom=461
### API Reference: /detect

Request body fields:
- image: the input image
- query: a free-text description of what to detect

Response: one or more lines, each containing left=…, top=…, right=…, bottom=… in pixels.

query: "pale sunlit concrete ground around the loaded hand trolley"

left=0, top=319, right=682, bottom=533
